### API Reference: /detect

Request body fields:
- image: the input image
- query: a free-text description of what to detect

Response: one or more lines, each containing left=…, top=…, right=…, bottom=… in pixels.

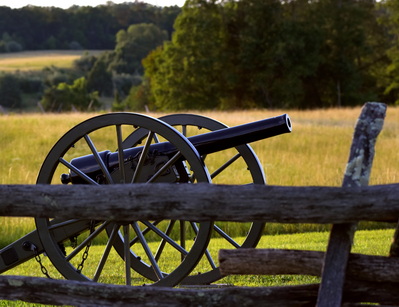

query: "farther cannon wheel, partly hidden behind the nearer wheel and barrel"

left=122, top=114, right=266, bottom=285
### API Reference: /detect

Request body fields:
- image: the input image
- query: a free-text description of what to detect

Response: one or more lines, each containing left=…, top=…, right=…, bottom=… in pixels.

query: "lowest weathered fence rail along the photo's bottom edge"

left=0, top=275, right=399, bottom=307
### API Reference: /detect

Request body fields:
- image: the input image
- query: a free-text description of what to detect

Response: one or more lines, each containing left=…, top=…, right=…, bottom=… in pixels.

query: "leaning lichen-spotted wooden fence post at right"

left=317, top=103, right=386, bottom=307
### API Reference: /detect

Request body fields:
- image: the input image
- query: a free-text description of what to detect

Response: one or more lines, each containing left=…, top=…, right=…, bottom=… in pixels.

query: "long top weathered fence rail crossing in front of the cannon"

left=0, top=184, right=399, bottom=223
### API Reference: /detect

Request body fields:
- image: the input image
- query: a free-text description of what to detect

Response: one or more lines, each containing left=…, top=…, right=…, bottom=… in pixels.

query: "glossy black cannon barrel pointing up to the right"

left=66, top=114, right=292, bottom=182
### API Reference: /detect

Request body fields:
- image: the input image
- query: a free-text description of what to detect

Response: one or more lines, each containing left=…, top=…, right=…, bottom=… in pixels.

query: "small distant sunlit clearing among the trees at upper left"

left=0, top=50, right=102, bottom=72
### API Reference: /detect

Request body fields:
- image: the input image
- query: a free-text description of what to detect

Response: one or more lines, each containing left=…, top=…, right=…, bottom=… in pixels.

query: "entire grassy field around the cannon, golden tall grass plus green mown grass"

left=0, top=107, right=399, bottom=306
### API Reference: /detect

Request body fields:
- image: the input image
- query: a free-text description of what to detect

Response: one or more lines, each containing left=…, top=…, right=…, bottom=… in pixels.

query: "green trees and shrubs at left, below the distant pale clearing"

left=0, top=23, right=168, bottom=112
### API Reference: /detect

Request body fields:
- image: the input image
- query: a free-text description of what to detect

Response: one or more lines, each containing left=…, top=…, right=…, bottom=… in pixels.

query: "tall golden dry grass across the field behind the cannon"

left=0, top=107, right=399, bottom=247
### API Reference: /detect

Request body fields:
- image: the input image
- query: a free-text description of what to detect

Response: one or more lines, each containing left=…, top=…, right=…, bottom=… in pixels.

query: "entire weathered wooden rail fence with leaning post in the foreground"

left=0, top=103, right=399, bottom=307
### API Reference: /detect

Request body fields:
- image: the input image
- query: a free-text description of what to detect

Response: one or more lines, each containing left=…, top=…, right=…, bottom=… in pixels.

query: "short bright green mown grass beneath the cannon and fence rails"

left=0, top=230, right=393, bottom=306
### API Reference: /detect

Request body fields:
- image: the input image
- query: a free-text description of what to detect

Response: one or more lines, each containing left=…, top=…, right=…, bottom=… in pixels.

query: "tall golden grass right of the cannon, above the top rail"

left=202, top=107, right=399, bottom=186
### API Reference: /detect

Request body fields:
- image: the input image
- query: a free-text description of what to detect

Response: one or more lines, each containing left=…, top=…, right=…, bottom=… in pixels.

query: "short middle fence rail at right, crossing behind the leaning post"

left=219, top=248, right=399, bottom=282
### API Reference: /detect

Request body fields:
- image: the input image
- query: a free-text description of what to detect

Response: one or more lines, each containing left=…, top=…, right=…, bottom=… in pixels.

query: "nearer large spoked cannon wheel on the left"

left=36, top=113, right=212, bottom=286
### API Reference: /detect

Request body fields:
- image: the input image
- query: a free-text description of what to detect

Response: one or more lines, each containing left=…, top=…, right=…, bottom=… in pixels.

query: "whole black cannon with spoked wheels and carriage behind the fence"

left=0, top=113, right=292, bottom=286
